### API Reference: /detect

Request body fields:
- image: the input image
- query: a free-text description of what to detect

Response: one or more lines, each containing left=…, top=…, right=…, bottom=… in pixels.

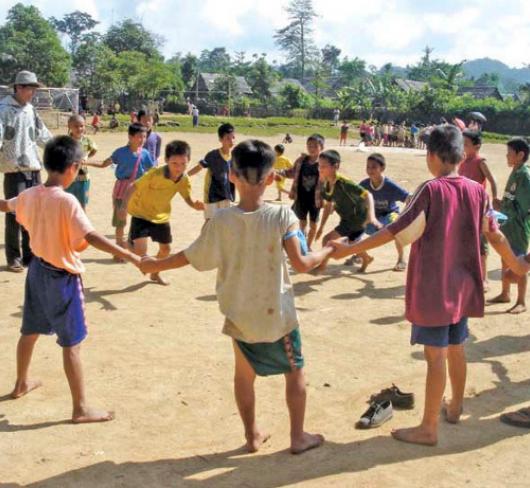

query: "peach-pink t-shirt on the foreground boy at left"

left=7, top=185, right=94, bottom=274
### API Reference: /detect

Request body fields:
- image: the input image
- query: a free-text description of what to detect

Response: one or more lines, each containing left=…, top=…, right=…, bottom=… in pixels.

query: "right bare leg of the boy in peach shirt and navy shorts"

left=63, top=344, right=114, bottom=424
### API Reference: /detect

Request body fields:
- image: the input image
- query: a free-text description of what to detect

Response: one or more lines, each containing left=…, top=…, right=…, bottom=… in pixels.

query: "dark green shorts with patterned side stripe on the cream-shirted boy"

left=236, top=327, right=304, bottom=376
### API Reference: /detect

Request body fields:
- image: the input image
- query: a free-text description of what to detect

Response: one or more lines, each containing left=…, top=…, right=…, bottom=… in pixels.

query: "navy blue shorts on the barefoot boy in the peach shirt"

left=20, top=257, right=87, bottom=347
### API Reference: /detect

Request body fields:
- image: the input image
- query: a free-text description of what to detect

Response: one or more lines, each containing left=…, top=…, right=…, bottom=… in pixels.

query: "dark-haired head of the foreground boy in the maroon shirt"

left=427, top=124, right=464, bottom=176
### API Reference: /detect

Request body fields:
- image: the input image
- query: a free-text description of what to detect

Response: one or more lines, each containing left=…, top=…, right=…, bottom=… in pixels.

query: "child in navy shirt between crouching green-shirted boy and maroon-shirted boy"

left=360, top=153, right=410, bottom=271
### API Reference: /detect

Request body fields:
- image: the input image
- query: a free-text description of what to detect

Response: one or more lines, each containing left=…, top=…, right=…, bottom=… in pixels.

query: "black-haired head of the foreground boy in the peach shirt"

left=43, top=136, right=83, bottom=188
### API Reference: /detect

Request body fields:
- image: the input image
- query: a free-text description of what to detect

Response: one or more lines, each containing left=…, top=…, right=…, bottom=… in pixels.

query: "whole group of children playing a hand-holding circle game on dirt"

left=0, top=117, right=530, bottom=454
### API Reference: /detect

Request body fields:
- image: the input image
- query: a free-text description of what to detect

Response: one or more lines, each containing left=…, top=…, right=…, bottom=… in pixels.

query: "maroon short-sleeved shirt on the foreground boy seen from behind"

left=387, top=176, right=497, bottom=327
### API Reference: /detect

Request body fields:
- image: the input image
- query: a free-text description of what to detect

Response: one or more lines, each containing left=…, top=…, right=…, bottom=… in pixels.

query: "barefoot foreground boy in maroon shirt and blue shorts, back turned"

left=333, top=125, right=528, bottom=446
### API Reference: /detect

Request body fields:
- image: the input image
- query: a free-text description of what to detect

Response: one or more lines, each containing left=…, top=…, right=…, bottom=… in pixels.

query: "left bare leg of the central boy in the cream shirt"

left=233, top=341, right=270, bottom=452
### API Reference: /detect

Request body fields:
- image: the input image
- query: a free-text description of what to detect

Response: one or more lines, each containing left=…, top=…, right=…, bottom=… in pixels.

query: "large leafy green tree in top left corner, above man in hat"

left=0, top=3, right=70, bottom=86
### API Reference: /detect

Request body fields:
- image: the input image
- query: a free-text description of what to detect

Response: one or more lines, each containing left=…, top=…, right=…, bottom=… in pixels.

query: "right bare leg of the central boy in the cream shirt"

left=285, top=369, right=324, bottom=454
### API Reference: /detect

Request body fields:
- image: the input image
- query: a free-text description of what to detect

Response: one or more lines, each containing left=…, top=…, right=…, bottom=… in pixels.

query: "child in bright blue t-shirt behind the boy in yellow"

left=91, top=123, right=153, bottom=252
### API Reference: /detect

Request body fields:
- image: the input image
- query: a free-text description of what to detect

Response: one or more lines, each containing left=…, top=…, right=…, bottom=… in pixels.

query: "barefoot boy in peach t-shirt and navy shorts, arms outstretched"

left=0, top=136, right=140, bottom=423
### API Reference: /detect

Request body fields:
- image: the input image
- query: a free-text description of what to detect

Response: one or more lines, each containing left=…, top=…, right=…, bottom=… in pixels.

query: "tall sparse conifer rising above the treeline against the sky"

left=274, top=0, right=317, bottom=83
